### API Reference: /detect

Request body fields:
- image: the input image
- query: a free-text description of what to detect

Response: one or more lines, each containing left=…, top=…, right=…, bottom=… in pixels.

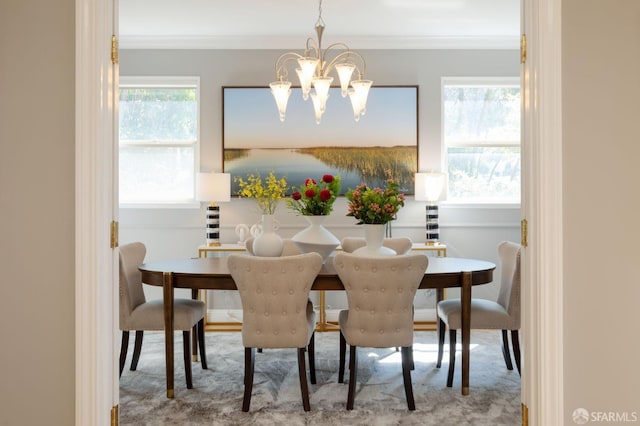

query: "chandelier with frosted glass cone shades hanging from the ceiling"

left=269, top=0, right=373, bottom=124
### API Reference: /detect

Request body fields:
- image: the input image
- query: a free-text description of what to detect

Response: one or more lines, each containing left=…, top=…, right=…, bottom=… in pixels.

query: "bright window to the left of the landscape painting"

left=119, top=77, right=200, bottom=206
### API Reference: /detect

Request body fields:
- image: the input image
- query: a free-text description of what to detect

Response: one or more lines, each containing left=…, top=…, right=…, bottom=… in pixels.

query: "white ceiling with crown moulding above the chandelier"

left=119, top=0, right=520, bottom=49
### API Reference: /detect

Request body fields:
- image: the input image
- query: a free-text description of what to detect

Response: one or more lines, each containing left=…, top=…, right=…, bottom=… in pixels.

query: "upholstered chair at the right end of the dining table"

left=436, top=241, right=521, bottom=387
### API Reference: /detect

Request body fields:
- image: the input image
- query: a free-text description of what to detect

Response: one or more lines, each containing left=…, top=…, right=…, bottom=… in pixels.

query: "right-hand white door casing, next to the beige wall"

left=521, top=0, right=564, bottom=425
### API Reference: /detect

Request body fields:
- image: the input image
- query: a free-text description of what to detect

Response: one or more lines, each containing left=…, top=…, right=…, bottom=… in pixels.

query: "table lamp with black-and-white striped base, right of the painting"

left=415, top=172, right=447, bottom=245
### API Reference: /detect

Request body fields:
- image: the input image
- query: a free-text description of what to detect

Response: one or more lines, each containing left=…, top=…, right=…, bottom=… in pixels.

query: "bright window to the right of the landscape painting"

left=442, top=78, right=520, bottom=203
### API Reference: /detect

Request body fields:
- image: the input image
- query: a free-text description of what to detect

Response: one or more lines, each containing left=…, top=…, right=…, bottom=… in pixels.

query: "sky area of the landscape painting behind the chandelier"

left=224, top=87, right=417, bottom=148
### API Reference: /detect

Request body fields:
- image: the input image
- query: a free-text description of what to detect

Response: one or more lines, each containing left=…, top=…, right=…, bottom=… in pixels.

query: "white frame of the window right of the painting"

left=440, top=76, right=522, bottom=208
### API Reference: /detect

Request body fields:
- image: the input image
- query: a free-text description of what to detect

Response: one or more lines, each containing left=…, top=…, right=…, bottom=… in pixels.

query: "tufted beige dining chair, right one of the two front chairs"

left=334, top=253, right=429, bottom=410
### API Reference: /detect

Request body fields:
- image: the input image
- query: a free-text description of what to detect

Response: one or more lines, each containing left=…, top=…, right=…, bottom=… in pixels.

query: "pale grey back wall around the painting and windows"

left=120, top=50, right=520, bottom=306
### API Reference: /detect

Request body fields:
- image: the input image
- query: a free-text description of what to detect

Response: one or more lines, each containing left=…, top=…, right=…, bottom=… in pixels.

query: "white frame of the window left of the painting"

left=116, top=75, right=201, bottom=209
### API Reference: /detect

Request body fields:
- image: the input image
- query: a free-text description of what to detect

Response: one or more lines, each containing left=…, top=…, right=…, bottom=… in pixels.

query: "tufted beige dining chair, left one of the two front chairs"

left=227, top=253, right=322, bottom=411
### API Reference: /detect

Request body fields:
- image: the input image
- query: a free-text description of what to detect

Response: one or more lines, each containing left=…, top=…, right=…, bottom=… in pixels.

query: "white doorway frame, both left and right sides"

left=75, top=0, right=564, bottom=426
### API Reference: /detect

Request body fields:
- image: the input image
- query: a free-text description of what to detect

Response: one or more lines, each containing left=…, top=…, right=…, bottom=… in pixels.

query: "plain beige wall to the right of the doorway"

left=562, top=0, right=640, bottom=424
